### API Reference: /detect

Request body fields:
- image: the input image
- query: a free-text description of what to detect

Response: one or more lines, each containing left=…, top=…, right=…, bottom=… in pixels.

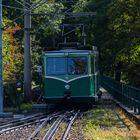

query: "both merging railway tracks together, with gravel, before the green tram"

left=0, top=110, right=80, bottom=140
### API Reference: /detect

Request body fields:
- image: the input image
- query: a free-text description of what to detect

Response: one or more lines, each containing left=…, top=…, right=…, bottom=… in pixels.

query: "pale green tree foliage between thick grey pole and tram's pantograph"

left=32, top=0, right=64, bottom=83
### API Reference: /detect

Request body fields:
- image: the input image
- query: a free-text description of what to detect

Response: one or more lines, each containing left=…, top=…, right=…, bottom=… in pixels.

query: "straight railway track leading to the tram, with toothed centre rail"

left=28, top=110, right=80, bottom=140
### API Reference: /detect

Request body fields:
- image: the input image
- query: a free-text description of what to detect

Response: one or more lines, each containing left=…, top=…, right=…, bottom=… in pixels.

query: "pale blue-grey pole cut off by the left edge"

left=0, top=0, right=3, bottom=114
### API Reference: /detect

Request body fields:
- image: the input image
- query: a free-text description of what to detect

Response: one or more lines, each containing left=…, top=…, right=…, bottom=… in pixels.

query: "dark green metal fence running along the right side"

left=101, top=76, right=140, bottom=114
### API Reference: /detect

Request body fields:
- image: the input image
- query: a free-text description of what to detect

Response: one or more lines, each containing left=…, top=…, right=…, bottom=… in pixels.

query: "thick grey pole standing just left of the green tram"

left=24, top=0, right=32, bottom=100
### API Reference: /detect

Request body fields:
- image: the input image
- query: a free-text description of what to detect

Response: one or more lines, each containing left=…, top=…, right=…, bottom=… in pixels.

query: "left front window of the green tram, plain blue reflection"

left=47, top=57, right=66, bottom=75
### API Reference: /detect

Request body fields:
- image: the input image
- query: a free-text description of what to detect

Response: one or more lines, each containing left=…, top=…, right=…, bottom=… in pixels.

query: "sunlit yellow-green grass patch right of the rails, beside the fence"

left=73, top=105, right=140, bottom=140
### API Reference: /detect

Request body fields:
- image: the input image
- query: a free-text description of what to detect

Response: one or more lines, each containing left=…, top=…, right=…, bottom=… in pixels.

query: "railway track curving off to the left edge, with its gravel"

left=0, top=112, right=60, bottom=140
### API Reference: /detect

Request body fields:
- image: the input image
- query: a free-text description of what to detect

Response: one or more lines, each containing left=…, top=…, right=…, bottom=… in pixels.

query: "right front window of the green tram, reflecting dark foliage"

left=68, top=57, right=87, bottom=75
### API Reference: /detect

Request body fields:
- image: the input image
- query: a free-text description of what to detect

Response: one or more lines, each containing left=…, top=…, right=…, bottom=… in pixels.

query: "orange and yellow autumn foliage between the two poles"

left=3, top=19, right=23, bottom=81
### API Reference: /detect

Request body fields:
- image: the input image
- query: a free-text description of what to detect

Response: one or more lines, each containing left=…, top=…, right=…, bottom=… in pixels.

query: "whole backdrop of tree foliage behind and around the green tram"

left=3, top=0, right=140, bottom=87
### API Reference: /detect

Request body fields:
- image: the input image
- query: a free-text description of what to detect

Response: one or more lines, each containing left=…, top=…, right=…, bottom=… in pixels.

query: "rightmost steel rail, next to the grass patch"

left=62, top=110, right=80, bottom=140
